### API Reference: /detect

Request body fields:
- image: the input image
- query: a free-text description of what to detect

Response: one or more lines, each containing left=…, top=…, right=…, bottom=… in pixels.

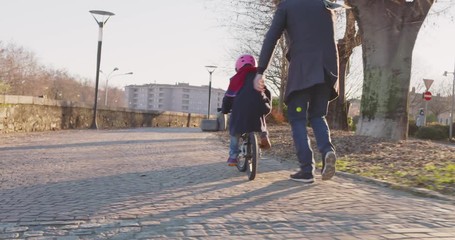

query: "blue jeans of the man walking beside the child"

left=288, top=84, right=335, bottom=174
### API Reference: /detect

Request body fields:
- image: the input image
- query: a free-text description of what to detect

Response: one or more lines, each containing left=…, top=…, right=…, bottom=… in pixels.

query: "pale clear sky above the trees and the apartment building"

left=0, top=0, right=455, bottom=96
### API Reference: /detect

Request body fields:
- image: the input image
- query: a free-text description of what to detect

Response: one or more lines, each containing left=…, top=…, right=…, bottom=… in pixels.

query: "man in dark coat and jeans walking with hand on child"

left=255, top=0, right=338, bottom=183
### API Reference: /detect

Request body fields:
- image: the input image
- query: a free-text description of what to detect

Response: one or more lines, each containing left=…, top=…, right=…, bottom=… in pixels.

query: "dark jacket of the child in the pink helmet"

left=221, top=68, right=272, bottom=136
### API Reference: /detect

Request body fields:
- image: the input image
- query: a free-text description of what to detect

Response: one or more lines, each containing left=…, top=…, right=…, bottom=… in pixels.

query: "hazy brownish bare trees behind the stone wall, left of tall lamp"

left=0, top=42, right=113, bottom=107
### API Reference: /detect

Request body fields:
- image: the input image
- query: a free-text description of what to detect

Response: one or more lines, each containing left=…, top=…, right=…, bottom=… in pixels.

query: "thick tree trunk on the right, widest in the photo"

left=350, top=0, right=433, bottom=140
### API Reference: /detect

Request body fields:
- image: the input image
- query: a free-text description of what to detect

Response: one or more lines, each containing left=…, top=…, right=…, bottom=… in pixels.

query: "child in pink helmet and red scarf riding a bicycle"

left=221, top=54, right=272, bottom=166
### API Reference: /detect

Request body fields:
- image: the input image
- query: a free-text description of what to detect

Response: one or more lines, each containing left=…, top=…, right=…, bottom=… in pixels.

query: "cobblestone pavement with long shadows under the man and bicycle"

left=0, top=128, right=455, bottom=240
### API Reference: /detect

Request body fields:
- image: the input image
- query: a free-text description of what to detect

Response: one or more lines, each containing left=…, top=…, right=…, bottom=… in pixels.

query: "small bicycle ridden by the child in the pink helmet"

left=237, top=132, right=261, bottom=180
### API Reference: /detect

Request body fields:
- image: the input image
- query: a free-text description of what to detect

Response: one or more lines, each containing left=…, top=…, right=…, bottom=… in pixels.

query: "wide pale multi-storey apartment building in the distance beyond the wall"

left=125, top=83, right=225, bottom=115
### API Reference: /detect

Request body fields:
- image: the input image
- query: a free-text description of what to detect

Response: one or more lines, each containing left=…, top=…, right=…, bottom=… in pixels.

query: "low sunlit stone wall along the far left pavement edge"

left=0, top=95, right=205, bottom=133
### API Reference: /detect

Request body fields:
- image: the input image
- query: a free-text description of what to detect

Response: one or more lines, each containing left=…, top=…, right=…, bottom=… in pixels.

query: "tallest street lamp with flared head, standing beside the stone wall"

left=89, top=10, right=115, bottom=129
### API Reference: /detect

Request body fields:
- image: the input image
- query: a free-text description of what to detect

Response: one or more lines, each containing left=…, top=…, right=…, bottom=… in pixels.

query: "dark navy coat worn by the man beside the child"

left=258, top=0, right=338, bottom=102
